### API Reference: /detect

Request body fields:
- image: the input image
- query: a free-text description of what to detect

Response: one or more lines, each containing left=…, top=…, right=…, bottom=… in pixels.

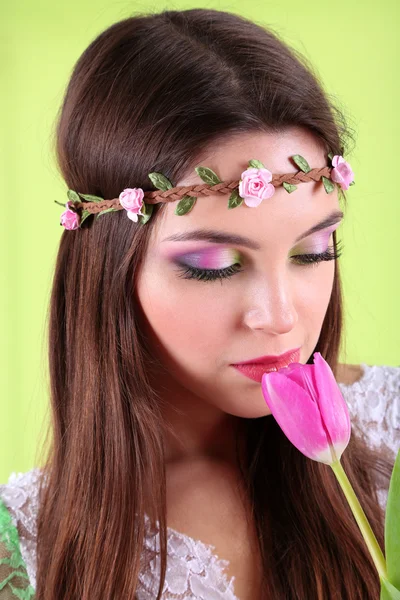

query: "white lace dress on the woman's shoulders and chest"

left=0, top=363, right=400, bottom=600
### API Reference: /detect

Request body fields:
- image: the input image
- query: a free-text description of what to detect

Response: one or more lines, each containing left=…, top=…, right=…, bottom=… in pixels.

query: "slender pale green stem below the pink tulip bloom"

left=330, top=459, right=387, bottom=579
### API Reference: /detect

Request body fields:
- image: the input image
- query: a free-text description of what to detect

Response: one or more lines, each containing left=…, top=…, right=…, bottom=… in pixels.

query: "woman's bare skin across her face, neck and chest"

left=136, top=128, right=355, bottom=600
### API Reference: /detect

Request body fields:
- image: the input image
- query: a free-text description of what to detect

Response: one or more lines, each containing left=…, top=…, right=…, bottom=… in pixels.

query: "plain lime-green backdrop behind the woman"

left=0, top=0, right=400, bottom=482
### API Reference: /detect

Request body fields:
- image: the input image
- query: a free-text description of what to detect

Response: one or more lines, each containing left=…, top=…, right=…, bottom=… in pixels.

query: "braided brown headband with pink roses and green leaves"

left=55, top=153, right=355, bottom=229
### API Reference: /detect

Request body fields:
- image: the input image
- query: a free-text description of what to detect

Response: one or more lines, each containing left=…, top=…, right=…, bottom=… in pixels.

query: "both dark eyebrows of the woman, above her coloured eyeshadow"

left=163, top=210, right=344, bottom=250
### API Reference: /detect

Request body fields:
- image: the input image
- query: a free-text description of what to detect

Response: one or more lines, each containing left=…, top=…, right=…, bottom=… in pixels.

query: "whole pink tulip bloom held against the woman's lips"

left=261, top=352, right=351, bottom=465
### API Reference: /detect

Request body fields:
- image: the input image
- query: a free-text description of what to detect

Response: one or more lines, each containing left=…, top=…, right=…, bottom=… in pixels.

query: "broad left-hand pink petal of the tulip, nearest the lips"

left=261, top=365, right=335, bottom=464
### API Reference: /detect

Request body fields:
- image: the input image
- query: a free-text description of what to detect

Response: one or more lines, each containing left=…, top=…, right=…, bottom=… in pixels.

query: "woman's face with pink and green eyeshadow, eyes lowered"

left=136, top=128, right=340, bottom=418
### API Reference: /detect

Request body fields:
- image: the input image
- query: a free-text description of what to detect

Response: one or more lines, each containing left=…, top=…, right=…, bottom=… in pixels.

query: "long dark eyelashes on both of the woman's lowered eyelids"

left=178, top=240, right=343, bottom=281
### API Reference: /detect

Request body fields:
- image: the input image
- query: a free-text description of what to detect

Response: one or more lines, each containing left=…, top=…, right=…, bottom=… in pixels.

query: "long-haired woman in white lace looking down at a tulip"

left=0, top=9, right=400, bottom=600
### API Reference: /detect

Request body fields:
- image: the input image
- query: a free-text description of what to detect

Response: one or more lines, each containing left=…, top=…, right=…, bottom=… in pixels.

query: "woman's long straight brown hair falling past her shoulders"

left=36, top=9, right=392, bottom=600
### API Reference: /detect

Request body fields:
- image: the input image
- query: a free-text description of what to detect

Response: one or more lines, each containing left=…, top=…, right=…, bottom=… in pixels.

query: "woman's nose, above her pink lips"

left=243, top=279, right=298, bottom=335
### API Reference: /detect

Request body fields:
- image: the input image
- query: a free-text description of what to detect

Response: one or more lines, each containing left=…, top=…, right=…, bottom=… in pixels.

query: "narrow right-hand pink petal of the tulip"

left=314, top=352, right=351, bottom=460
